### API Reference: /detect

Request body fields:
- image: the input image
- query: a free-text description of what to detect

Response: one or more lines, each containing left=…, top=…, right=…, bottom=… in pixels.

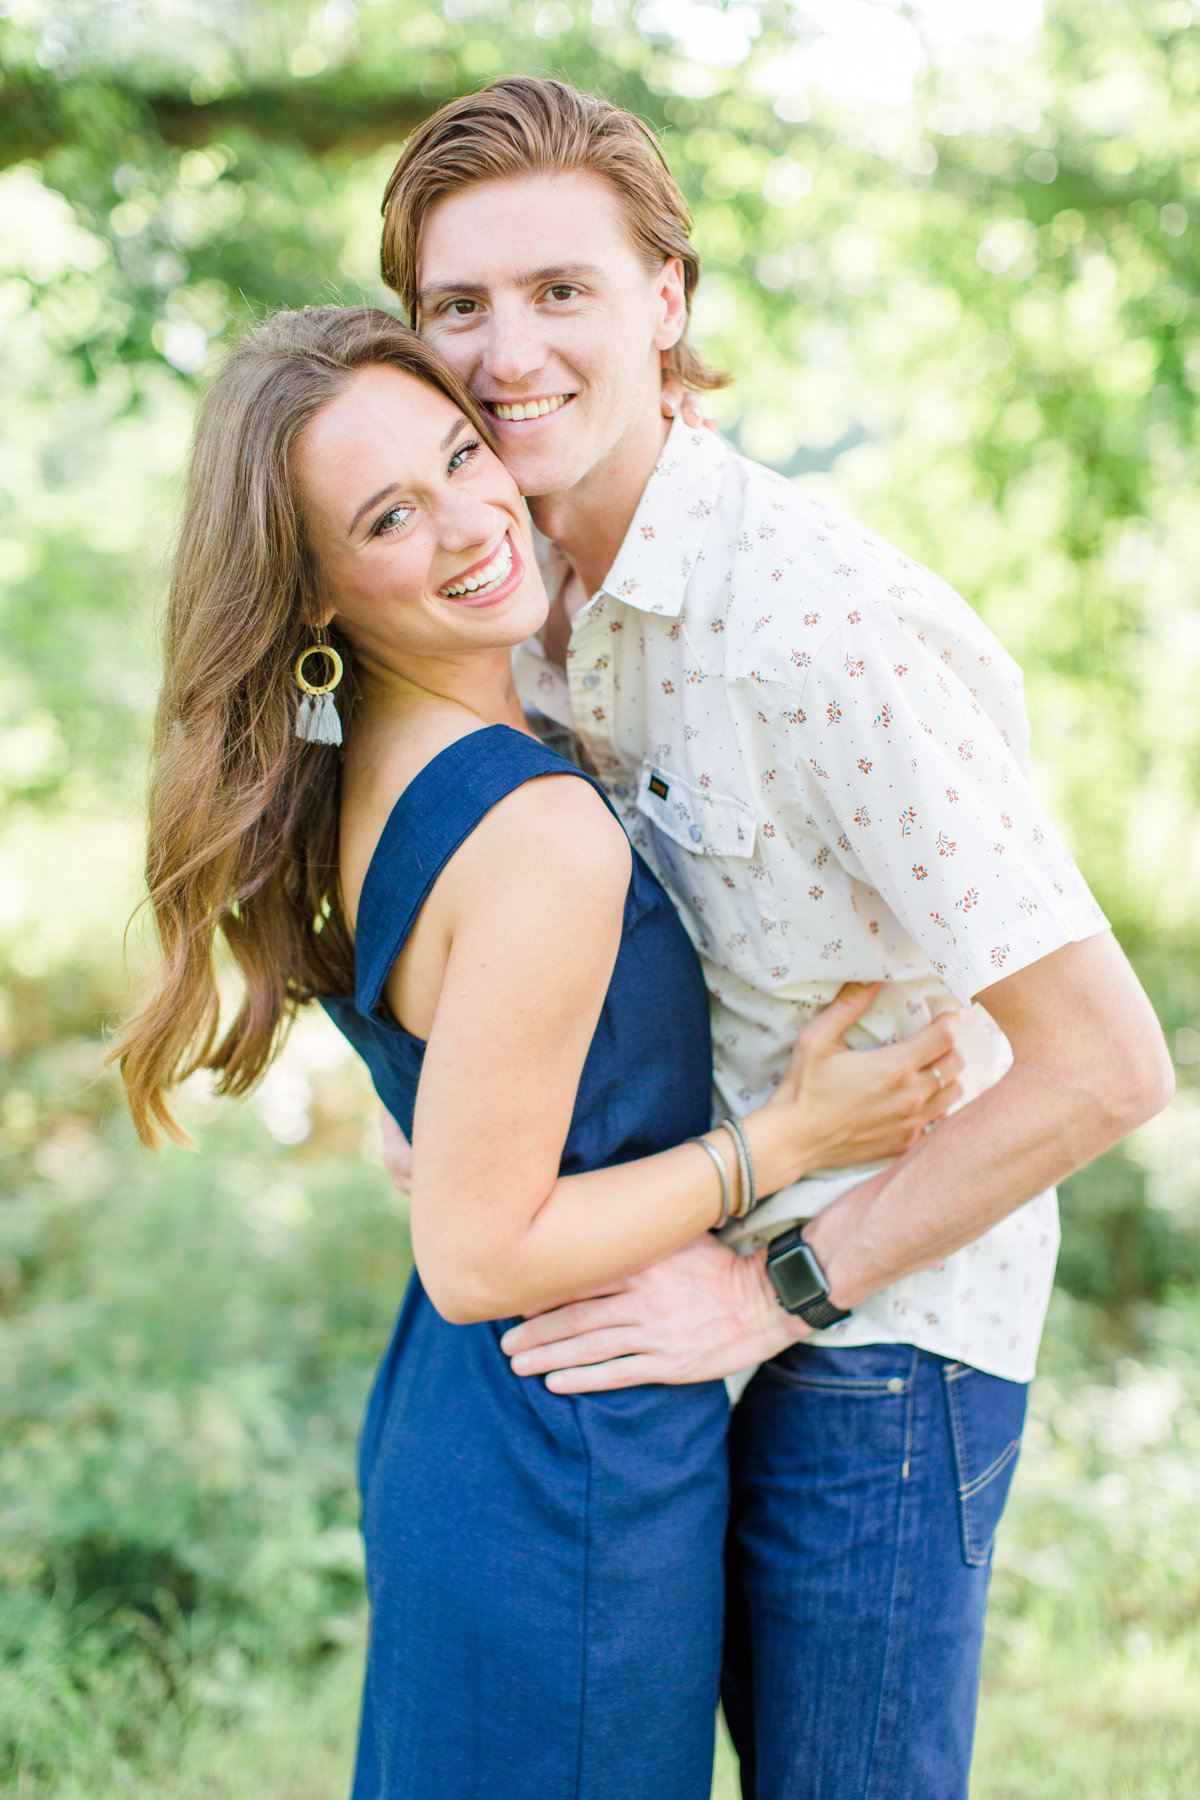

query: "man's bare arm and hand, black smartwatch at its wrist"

left=504, top=932, right=1173, bottom=1393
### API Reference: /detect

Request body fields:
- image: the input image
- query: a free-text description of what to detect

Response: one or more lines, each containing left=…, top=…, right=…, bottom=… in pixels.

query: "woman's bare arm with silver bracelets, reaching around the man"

left=402, top=776, right=961, bottom=1323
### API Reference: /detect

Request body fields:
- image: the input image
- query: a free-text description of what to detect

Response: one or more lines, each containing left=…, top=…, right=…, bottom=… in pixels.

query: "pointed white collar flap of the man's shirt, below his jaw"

left=601, top=419, right=730, bottom=619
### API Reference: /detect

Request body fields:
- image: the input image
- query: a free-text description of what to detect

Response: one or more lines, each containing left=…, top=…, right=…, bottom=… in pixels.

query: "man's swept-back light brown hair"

left=380, top=76, right=729, bottom=389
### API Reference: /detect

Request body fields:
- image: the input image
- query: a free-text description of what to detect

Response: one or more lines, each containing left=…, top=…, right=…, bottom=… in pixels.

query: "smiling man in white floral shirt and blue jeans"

left=383, top=79, right=1171, bottom=1800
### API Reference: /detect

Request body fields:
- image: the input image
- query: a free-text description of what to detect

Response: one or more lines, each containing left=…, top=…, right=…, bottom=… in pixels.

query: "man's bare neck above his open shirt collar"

left=529, top=410, right=671, bottom=598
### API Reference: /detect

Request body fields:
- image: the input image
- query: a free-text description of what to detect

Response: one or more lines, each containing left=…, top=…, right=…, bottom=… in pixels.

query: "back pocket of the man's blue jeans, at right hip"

left=941, top=1363, right=1027, bottom=1568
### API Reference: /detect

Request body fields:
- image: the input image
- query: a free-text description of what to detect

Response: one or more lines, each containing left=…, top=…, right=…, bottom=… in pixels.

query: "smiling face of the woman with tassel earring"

left=297, top=364, right=547, bottom=666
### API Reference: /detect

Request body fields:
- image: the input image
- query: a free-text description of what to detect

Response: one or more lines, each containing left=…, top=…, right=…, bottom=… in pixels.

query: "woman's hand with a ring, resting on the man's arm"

left=761, top=981, right=963, bottom=1174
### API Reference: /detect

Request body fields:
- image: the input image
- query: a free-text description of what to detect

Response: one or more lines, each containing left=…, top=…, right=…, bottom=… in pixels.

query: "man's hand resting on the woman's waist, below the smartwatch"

left=500, top=1233, right=808, bottom=1393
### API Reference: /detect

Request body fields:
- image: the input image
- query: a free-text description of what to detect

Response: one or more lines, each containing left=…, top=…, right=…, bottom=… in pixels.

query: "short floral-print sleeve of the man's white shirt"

left=799, top=614, right=1108, bottom=1003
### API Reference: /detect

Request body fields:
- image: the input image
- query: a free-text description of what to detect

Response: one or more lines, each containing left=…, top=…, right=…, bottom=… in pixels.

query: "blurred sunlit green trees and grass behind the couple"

left=0, top=0, right=1200, bottom=1800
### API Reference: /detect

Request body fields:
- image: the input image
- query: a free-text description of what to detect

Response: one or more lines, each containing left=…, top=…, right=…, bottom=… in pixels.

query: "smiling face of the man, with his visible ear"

left=417, top=171, right=685, bottom=497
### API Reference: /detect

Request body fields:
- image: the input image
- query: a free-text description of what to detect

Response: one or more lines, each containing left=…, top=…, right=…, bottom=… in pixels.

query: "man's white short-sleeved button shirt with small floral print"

left=516, top=421, right=1106, bottom=1381
